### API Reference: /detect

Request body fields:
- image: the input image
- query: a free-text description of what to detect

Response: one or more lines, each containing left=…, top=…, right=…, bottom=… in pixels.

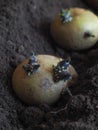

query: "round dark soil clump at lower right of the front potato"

left=67, top=95, right=94, bottom=121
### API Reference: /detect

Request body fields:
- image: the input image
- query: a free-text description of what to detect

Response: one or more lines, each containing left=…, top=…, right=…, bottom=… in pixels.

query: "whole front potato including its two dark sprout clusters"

left=12, top=53, right=78, bottom=104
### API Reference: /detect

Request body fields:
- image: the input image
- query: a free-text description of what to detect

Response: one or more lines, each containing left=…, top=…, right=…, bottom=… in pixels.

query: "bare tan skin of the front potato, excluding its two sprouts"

left=12, top=55, right=78, bottom=105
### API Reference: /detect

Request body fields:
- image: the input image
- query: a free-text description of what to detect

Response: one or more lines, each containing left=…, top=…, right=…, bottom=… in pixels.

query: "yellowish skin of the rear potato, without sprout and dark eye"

left=50, top=8, right=98, bottom=50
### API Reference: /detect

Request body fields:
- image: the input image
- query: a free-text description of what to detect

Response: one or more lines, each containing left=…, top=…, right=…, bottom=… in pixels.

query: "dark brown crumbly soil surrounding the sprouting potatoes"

left=0, top=0, right=98, bottom=130
